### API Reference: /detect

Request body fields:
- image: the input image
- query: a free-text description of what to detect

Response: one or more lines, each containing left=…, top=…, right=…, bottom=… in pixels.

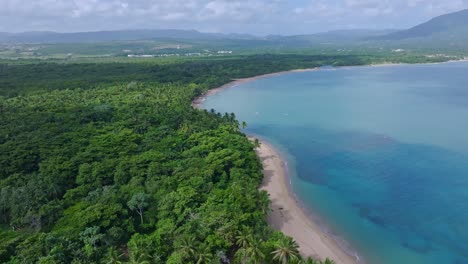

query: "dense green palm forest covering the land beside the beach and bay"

left=0, top=52, right=460, bottom=264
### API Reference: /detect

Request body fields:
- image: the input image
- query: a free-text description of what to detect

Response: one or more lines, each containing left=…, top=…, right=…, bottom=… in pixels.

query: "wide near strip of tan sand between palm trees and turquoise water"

left=252, top=138, right=359, bottom=264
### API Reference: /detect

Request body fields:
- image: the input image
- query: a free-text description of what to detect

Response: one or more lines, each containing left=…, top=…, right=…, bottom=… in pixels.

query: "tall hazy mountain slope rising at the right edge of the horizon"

left=375, top=9, right=468, bottom=41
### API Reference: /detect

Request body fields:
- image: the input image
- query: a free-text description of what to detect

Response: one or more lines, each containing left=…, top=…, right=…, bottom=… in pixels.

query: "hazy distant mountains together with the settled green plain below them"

left=0, top=10, right=468, bottom=61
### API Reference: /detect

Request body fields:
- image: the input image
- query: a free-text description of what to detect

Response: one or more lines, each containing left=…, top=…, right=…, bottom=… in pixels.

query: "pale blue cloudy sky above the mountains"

left=0, top=0, right=468, bottom=35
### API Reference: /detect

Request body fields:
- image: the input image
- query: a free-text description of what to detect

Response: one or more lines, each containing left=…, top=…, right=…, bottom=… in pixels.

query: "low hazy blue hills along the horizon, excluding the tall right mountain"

left=0, top=29, right=396, bottom=47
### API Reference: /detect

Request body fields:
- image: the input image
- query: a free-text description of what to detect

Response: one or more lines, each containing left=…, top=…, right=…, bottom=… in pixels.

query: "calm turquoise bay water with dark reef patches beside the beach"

left=203, top=63, right=468, bottom=264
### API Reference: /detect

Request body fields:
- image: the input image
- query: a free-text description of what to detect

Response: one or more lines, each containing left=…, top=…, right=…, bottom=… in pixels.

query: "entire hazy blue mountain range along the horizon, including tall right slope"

left=0, top=10, right=468, bottom=46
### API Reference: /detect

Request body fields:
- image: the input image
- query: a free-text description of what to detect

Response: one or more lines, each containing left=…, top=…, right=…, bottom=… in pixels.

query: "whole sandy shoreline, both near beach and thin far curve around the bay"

left=192, top=59, right=468, bottom=264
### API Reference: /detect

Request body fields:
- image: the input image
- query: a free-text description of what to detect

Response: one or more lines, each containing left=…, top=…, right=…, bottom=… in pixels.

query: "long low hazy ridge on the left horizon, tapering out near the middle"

left=0, top=29, right=254, bottom=43
